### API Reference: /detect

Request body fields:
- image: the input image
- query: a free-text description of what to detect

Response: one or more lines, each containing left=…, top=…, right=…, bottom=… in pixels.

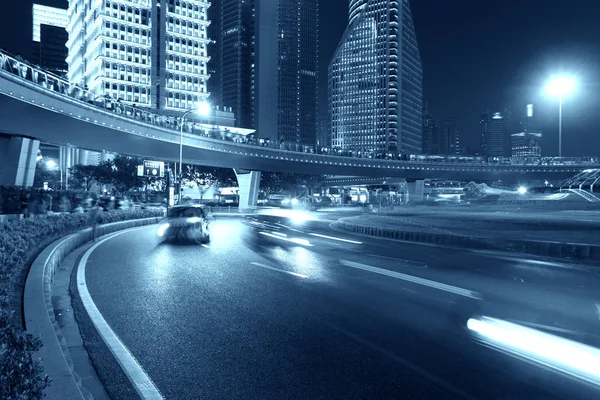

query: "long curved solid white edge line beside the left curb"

left=77, top=228, right=164, bottom=400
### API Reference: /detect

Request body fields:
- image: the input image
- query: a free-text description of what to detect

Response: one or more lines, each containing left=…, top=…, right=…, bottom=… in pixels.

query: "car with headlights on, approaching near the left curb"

left=157, top=204, right=210, bottom=243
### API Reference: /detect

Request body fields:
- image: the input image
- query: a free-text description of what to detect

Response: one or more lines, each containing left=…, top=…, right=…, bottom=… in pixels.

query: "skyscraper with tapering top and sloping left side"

left=328, top=0, right=423, bottom=154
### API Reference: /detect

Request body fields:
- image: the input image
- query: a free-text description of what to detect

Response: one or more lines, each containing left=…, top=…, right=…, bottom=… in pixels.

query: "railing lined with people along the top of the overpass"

left=0, top=50, right=600, bottom=166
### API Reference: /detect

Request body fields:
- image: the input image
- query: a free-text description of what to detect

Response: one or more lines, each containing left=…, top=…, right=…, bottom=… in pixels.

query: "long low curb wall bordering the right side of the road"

left=337, top=221, right=600, bottom=261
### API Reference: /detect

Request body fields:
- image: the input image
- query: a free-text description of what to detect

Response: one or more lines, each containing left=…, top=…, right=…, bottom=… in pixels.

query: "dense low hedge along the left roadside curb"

left=0, top=210, right=163, bottom=399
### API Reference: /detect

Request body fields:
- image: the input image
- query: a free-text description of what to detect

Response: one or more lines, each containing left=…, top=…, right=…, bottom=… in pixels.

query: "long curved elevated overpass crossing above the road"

left=0, top=52, right=590, bottom=206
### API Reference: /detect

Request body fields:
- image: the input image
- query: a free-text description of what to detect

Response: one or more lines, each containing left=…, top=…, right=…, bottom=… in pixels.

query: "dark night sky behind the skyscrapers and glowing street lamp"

left=0, top=0, right=600, bottom=156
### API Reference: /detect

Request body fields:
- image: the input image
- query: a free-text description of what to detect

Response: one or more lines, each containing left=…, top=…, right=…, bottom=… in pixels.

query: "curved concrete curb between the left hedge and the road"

left=23, top=217, right=162, bottom=400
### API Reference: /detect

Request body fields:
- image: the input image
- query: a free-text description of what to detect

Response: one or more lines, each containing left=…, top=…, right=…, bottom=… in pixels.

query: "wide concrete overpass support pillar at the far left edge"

left=0, top=136, right=40, bottom=187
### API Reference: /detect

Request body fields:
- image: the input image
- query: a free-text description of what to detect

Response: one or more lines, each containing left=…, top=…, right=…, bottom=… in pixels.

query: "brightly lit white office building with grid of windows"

left=67, top=0, right=210, bottom=111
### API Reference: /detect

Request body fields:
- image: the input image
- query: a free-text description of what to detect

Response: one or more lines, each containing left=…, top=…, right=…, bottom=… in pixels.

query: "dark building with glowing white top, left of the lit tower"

left=32, top=4, right=69, bottom=76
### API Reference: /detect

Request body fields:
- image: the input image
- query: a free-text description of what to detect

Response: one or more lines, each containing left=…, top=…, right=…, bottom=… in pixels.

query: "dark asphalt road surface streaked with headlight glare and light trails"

left=78, top=213, right=600, bottom=400
